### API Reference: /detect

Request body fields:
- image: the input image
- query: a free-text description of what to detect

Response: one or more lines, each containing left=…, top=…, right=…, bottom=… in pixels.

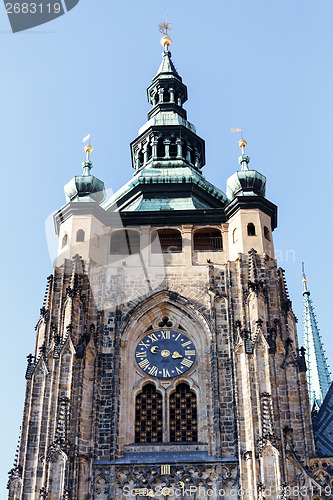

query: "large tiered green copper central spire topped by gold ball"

left=104, top=35, right=228, bottom=211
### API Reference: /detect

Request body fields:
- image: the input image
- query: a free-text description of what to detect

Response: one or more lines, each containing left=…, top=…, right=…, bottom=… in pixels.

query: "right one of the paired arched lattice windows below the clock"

left=170, top=383, right=198, bottom=442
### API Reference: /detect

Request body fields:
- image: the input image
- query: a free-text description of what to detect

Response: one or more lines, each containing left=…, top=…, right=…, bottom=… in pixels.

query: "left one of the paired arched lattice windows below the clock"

left=135, top=384, right=163, bottom=443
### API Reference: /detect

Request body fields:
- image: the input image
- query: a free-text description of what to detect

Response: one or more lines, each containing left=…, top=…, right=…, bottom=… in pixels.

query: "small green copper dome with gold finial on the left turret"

left=64, top=144, right=105, bottom=203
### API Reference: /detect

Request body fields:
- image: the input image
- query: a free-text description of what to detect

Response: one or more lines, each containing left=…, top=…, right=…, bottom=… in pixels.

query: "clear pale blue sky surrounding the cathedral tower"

left=0, top=0, right=333, bottom=492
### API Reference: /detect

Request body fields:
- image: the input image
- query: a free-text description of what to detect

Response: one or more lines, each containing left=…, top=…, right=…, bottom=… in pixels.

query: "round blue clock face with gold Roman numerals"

left=135, top=330, right=196, bottom=378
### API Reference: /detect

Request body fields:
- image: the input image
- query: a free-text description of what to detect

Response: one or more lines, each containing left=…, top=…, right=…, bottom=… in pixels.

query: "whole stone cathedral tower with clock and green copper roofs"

left=8, top=37, right=328, bottom=500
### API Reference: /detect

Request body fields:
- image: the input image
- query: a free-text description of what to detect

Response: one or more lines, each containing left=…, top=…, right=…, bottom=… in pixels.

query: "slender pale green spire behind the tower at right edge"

left=303, top=265, right=331, bottom=406
